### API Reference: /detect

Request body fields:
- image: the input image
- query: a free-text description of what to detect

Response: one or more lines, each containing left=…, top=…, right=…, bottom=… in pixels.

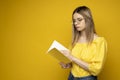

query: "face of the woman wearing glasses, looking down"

left=73, top=13, right=86, bottom=31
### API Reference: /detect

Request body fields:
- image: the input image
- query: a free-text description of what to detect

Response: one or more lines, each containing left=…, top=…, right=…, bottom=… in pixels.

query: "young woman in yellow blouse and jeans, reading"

left=60, top=6, right=107, bottom=80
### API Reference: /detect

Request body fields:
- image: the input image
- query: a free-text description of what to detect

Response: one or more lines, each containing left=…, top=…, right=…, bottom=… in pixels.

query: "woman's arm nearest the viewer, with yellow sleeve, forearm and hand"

left=62, top=39, right=107, bottom=75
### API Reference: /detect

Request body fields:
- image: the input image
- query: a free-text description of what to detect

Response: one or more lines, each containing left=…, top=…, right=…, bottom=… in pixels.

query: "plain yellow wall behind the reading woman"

left=0, top=0, right=120, bottom=80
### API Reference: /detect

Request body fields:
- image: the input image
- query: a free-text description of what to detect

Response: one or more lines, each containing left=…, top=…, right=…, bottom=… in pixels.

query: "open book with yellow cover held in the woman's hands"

left=47, top=40, right=71, bottom=63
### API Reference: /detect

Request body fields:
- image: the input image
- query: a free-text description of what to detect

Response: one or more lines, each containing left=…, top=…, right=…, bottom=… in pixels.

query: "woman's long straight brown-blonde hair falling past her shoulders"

left=72, top=6, right=96, bottom=46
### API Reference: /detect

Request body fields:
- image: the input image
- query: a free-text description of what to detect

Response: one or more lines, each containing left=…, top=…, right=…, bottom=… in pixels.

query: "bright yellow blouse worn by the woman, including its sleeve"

left=71, top=37, right=107, bottom=77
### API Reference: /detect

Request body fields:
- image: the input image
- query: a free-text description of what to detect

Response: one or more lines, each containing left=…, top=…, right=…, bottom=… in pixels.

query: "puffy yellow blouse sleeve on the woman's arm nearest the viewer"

left=88, top=39, right=107, bottom=75
